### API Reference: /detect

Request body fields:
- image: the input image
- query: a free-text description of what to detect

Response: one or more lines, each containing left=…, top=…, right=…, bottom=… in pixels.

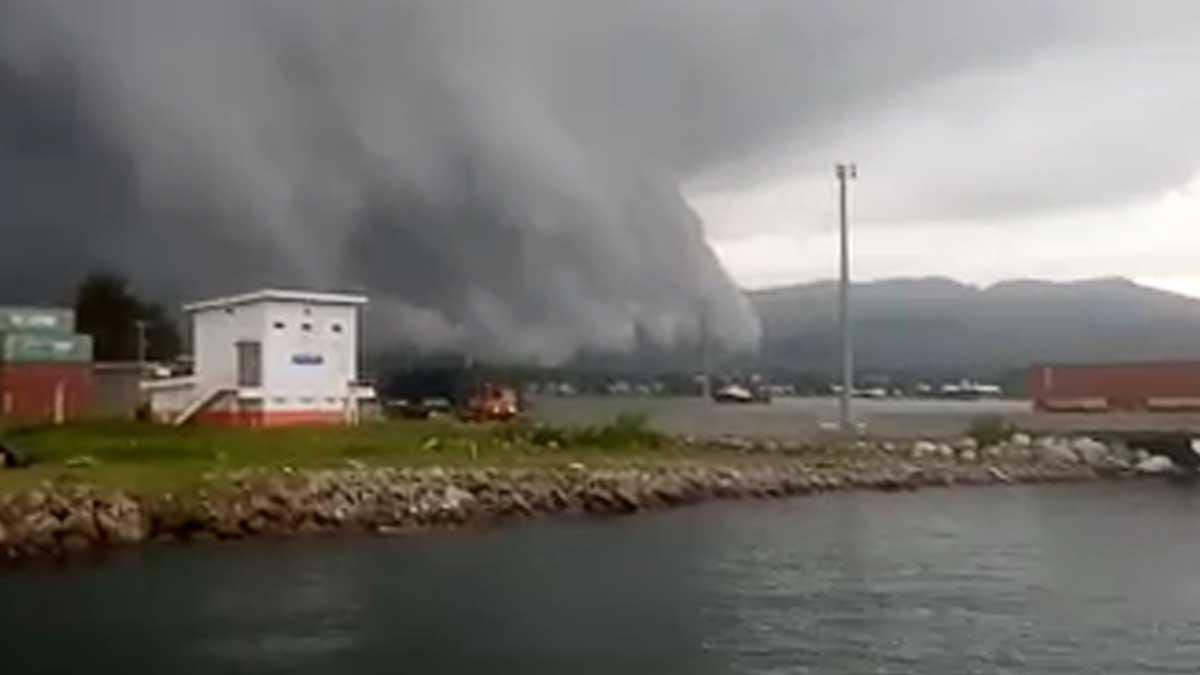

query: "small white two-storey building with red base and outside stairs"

left=143, top=289, right=374, bottom=426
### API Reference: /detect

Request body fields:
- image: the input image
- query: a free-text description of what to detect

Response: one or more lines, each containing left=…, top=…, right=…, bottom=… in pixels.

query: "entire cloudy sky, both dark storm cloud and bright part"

left=0, top=0, right=1200, bottom=362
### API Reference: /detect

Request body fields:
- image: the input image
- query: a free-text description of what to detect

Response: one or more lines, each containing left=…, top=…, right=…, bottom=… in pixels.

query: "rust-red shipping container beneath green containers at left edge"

left=0, top=363, right=91, bottom=422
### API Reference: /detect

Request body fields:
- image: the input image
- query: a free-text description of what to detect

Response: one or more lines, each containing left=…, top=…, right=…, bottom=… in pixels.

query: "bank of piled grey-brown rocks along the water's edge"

left=0, top=435, right=1171, bottom=560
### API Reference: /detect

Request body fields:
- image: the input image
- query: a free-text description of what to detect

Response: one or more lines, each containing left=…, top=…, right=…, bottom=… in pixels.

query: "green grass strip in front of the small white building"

left=0, top=416, right=748, bottom=494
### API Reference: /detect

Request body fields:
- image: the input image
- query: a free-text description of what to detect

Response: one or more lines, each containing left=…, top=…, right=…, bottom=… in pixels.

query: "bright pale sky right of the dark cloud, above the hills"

left=688, top=1, right=1200, bottom=295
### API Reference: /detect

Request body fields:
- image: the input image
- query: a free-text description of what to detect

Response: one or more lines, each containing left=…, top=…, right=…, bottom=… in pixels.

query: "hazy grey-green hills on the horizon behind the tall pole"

left=749, top=277, right=1200, bottom=376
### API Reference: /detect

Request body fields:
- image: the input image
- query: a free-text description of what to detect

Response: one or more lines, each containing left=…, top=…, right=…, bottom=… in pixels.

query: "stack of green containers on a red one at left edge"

left=0, top=307, right=92, bottom=424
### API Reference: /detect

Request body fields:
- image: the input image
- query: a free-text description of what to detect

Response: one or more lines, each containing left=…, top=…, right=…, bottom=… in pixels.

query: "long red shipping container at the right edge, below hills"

left=1028, top=362, right=1200, bottom=412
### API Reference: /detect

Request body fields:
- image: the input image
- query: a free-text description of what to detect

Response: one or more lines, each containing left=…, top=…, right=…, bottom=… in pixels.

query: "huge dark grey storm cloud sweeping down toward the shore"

left=0, top=0, right=1190, bottom=360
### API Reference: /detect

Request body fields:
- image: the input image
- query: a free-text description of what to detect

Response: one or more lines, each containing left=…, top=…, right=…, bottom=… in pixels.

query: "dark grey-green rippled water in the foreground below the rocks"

left=0, top=483, right=1200, bottom=675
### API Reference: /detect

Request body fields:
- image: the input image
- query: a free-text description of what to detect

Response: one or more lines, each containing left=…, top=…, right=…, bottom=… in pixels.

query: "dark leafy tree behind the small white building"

left=76, top=273, right=182, bottom=360
